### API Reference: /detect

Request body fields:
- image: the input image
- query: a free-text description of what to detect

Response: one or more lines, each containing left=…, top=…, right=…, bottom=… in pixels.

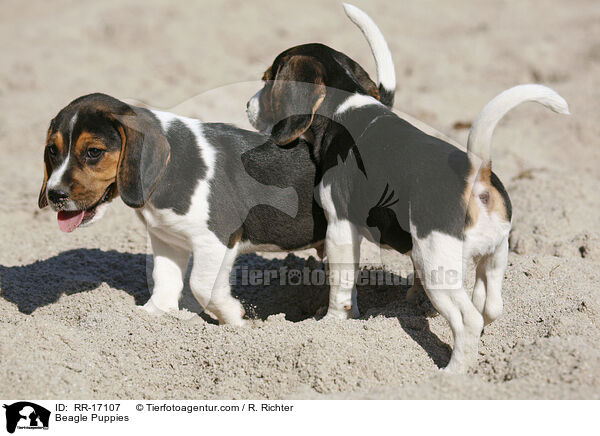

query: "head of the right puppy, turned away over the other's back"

left=247, top=44, right=379, bottom=145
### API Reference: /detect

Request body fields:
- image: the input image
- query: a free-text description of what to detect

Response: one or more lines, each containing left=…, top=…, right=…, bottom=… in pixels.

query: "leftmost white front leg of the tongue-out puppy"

left=142, top=232, right=190, bottom=315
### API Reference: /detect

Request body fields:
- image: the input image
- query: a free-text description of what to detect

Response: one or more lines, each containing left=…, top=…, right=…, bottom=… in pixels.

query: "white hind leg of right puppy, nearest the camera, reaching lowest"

left=413, top=232, right=483, bottom=372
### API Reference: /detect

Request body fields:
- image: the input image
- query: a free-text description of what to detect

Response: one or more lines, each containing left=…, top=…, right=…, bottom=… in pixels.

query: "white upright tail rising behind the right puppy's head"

left=343, top=3, right=396, bottom=108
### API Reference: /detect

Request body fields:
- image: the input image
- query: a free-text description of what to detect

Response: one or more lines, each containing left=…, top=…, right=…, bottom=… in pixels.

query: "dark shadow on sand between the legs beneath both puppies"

left=231, top=253, right=452, bottom=368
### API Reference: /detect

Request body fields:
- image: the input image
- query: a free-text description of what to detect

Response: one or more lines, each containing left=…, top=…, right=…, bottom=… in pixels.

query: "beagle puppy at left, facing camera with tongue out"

left=39, top=2, right=395, bottom=325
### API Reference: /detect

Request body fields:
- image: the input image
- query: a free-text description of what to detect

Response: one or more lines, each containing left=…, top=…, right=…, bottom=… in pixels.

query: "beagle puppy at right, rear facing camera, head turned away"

left=248, top=5, right=568, bottom=371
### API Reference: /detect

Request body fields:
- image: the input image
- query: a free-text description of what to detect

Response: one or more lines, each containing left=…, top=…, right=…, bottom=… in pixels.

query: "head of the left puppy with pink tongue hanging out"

left=38, top=94, right=170, bottom=232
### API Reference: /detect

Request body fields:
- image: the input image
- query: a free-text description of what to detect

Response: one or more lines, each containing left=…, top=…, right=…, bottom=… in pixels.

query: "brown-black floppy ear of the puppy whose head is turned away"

left=271, top=55, right=327, bottom=145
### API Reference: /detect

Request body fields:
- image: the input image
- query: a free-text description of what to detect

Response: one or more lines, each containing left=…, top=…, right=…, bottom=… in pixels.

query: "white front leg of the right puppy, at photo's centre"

left=325, top=219, right=360, bottom=319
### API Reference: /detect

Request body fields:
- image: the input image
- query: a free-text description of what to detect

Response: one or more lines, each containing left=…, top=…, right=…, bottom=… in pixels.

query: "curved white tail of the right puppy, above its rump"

left=467, top=84, right=570, bottom=166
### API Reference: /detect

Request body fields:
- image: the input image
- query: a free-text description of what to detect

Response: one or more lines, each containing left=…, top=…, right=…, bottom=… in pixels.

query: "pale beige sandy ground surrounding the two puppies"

left=0, top=0, right=600, bottom=399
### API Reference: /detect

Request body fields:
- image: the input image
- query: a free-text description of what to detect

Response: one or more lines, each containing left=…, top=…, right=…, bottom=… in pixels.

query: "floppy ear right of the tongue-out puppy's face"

left=115, top=110, right=171, bottom=208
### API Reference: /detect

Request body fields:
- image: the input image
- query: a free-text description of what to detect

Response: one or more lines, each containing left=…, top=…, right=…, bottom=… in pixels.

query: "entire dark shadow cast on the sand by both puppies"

left=0, top=249, right=450, bottom=367
